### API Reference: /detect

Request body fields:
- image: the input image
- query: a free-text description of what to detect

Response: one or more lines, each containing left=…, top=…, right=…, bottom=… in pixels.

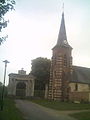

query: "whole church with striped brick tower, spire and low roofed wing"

left=48, top=12, right=90, bottom=102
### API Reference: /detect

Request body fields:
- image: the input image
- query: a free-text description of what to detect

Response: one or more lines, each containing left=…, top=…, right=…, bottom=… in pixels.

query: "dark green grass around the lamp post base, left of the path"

left=0, top=99, right=24, bottom=120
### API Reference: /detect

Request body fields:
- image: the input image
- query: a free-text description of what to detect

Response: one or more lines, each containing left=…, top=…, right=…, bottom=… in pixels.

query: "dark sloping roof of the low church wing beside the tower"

left=70, top=66, right=90, bottom=84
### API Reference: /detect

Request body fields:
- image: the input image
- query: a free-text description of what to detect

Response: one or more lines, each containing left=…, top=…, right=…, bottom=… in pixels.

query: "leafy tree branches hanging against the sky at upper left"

left=0, top=0, right=15, bottom=45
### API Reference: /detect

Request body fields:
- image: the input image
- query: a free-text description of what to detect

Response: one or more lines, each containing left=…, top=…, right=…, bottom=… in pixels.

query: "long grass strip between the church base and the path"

left=32, top=99, right=90, bottom=111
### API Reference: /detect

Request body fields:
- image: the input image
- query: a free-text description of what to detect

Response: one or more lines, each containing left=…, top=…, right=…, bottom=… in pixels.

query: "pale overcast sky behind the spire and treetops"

left=0, top=0, right=90, bottom=84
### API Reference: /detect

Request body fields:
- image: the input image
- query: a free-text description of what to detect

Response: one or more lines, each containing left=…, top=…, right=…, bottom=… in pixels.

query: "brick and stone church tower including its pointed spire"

left=48, top=12, right=72, bottom=100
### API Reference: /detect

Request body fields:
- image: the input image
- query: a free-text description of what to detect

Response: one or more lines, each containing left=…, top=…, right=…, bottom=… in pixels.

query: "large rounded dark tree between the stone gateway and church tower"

left=31, top=57, right=51, bottom=96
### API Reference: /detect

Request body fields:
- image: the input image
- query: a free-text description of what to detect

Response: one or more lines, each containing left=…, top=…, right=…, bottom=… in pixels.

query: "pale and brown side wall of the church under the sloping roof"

left=69, top=83, right=90, bottom=102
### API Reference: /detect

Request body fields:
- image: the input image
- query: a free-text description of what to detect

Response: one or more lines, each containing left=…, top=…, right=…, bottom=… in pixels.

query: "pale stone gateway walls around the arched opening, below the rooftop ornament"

left=8, top=73, right=34, bottom=97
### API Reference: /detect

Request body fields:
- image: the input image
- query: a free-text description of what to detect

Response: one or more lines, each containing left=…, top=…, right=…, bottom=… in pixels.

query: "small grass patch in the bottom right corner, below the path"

left=70, top=111, right=90, bottom=120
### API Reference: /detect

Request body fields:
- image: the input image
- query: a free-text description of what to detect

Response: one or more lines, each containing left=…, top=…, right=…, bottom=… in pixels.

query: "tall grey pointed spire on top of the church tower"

left=57, top=11, right=67, bottom=46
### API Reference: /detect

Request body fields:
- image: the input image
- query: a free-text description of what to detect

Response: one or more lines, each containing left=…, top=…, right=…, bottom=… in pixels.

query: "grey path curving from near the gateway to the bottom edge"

left=15, top=100, right=76, bottom=120
